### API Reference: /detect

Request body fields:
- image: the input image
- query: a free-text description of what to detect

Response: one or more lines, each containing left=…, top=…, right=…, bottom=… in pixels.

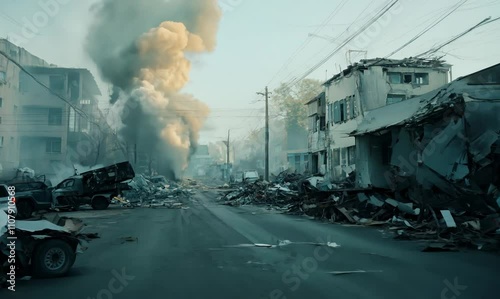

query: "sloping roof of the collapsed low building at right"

left=350, top=64, right=500, bottom=136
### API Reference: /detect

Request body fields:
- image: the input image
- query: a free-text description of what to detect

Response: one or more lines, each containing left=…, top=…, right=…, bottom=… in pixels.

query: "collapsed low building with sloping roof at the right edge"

left=351, top=64, right=500, bottom=214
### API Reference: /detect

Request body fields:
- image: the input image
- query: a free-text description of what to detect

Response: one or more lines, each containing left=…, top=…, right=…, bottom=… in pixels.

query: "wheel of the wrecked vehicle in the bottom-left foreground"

left=32, top=239, right=76, bottom=278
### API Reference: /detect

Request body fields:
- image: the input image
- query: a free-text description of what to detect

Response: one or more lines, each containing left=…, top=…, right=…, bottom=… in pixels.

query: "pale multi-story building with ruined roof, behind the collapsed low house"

left=324, top=58, right=451, bottom=180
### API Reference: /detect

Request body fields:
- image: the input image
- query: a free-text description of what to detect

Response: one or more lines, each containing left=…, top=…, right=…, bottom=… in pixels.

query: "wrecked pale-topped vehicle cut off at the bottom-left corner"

left=0, top=212, right=88, bottom=287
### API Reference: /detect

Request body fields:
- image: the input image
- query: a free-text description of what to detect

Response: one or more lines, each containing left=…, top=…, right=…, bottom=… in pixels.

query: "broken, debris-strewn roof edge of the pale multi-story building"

left=323, top=57, right=451, bottom=85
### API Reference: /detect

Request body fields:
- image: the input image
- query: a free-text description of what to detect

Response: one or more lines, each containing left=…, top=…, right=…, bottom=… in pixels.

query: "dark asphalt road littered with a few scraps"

left=0, top=192, right=500, bottom=299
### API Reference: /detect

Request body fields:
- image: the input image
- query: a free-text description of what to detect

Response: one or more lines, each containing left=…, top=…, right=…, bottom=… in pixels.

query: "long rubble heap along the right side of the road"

left=220, top=170, right=500, bottom=251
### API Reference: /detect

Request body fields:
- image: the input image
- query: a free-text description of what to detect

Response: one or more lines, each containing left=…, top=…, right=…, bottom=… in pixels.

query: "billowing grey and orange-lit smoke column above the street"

left=87, top=0, right=221, bottom=177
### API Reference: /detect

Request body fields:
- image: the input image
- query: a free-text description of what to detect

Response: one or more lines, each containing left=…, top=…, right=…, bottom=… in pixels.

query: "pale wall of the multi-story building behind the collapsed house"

left=326, top=62, right=449, bottom=180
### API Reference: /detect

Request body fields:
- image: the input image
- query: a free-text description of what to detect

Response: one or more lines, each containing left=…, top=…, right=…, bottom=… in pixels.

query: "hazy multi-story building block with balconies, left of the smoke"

left=18, top=67, right=100, bottom=175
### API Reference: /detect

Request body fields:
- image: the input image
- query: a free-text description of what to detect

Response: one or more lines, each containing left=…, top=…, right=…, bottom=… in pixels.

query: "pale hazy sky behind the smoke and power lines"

left=0, top=0, right=500, bottom=142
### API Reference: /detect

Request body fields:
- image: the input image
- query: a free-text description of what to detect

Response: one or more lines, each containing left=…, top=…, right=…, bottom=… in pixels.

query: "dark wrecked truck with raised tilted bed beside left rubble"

left=52, top=162, right=135, bottom=210
